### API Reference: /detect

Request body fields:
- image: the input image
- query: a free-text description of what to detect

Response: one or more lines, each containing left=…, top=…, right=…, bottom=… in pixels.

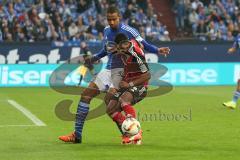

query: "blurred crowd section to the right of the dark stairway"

left=173, top=0, right=240, bottom=41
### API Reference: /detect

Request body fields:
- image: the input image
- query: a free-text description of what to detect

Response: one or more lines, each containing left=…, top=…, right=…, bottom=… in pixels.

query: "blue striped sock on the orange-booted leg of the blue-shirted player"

left=75, top=101, right=89, bottom=138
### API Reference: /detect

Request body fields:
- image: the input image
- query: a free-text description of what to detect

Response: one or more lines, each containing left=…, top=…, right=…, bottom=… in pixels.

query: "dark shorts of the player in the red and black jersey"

left=113, top=86, right=147, bottom=105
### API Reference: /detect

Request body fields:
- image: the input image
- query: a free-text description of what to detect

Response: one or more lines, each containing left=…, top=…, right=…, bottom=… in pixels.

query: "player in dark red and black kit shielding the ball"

left=107, top=33, right=151, bottom=144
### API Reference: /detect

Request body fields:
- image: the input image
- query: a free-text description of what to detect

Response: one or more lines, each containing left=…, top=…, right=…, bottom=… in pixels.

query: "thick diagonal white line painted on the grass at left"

left=7, top=99, right=46, bottom=126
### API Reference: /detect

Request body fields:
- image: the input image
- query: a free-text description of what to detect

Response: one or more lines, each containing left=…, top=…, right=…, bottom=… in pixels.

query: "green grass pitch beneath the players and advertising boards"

left=0, top=86, right=240, bottom=160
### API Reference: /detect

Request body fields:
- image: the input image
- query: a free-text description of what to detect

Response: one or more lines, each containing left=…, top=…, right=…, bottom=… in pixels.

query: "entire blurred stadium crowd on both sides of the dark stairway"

left=0, top=0, right=240, bottom=42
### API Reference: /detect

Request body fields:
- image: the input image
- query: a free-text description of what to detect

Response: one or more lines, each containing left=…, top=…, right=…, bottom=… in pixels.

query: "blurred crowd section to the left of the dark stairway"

left=0, top=0, right=170, bottom=42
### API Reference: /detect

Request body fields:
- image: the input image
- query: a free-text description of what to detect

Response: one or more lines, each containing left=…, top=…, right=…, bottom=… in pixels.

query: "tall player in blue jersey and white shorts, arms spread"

left=59, top=6, right=170, bottom=143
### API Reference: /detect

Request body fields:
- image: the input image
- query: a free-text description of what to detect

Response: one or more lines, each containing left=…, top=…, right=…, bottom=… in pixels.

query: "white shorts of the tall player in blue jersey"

left=92, top=68, right=123, bottom=91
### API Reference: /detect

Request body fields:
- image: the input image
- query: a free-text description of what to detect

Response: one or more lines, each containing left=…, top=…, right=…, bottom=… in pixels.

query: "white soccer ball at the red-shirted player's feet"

left=122, top=118, right=141, bottom=136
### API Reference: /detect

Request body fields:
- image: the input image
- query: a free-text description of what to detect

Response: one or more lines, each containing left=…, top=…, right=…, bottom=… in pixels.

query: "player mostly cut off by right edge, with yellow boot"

left=223, top=35, right=240, bottom=109
